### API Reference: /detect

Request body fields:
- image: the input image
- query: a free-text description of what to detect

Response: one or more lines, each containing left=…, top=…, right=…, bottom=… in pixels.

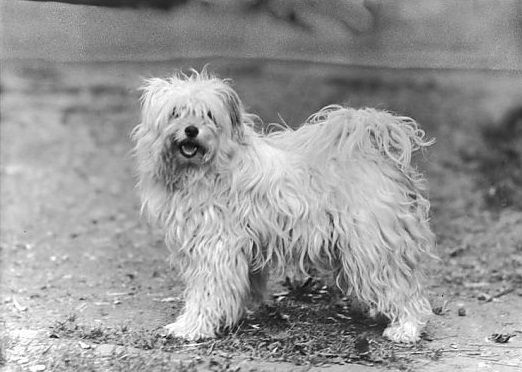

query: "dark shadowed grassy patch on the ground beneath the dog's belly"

left=201, top=278, right=416, bottom=364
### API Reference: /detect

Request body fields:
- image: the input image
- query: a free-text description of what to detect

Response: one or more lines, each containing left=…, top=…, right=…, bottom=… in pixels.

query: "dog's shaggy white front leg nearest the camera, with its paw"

left=165, top=239, right=250, bottom=340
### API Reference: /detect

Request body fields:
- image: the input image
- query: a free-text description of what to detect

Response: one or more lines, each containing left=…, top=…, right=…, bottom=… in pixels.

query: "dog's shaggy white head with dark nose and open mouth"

left=133, top=70, right=244, bottom=186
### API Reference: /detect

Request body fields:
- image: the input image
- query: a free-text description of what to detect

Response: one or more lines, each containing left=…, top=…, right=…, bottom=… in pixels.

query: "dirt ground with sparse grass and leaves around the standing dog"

left=0, top=60, right=522, bottom=371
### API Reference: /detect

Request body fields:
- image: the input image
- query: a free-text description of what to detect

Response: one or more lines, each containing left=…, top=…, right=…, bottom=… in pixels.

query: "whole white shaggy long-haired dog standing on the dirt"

left=133, top=71, right=434, bottom=342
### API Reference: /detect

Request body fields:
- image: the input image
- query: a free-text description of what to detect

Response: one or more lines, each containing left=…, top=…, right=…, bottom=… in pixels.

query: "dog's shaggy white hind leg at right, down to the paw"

left=337, top=214, right=430, bottom=343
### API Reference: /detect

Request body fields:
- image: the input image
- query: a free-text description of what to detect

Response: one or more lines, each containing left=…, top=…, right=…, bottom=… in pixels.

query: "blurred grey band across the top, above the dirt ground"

left=0, top=0, right=522, bottom=70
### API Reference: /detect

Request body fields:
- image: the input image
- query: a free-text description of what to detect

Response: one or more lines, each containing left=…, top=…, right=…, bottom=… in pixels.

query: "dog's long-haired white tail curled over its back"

left=278, top=105, right=434, bottom=169
